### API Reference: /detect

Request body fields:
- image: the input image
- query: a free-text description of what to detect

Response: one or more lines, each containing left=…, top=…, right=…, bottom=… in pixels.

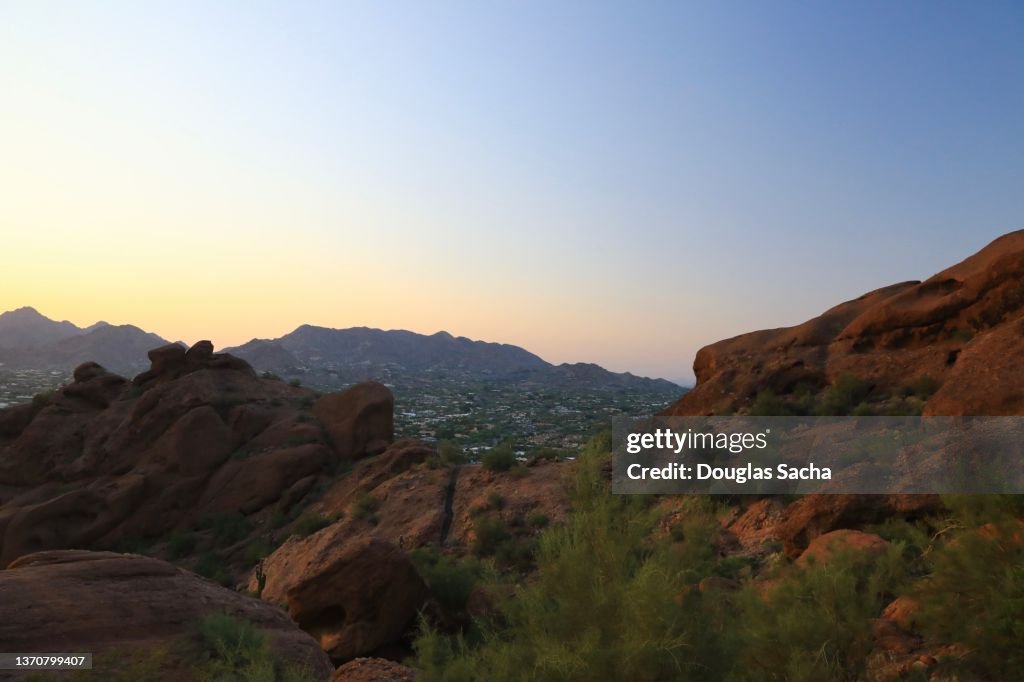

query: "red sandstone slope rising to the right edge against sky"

left=664, top=230, right=1024, bottom=416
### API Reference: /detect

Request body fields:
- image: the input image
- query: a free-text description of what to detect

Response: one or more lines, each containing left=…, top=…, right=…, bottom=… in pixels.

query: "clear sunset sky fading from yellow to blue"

left=0, top=0, right=1024, bottom=381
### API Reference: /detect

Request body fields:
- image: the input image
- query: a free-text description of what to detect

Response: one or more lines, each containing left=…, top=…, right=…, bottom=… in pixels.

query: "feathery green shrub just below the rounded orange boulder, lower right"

left=732, top=545, right=906, bottom=682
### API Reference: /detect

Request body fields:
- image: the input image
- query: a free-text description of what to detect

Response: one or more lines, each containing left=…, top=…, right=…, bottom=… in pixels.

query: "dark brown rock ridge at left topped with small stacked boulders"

left=0, top=341, right=392, bottom=567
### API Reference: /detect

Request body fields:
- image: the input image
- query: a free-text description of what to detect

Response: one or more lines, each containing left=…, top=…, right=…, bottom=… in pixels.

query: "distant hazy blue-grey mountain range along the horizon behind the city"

left=0, top=307, right=679, bottom=394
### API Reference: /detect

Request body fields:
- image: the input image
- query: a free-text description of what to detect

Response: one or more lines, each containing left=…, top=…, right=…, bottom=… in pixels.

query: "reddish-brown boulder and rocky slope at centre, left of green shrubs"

left=249, top=440, right=568, bottom=663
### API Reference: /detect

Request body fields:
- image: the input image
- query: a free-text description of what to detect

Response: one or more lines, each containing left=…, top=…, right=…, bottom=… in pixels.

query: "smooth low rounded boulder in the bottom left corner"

left=0, top=550, right=333, bottom=680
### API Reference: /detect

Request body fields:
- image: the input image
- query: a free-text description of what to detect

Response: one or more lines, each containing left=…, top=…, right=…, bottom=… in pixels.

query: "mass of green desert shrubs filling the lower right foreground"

left=413, top=432, right=1024, bottom=681
